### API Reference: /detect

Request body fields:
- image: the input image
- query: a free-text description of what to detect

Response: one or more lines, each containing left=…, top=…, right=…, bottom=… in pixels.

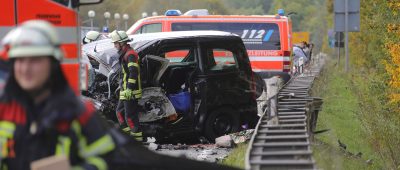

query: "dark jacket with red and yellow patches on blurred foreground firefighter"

left=0, top=88, right=116, bottom=170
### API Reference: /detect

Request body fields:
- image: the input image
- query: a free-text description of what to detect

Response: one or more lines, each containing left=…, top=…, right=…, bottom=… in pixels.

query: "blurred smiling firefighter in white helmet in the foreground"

left=0, top=20, right=117, bottom=170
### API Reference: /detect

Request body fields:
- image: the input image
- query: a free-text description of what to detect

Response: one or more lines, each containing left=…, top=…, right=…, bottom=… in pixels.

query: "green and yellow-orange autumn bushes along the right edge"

left=349, top=0, right=400, bottom=169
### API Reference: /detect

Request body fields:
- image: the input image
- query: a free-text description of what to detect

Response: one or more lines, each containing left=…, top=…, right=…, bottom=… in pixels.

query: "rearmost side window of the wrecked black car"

left=206, top=48, right=239, bottom=71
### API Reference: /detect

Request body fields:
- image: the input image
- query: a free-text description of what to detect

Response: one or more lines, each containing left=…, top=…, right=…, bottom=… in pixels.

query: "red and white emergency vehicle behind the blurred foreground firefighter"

left=0, top=0, right=102, bottom=94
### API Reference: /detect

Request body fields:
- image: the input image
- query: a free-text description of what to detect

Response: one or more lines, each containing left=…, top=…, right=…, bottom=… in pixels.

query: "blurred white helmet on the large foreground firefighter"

left=8, top=20, right=63, bottom=61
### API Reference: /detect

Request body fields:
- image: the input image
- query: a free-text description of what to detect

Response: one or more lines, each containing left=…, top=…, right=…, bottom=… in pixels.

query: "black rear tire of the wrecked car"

left=204, top=108, right=240, bottom=142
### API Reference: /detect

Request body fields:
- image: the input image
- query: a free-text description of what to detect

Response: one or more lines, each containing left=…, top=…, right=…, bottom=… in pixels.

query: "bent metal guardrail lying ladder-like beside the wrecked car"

left=245, top=54, right=322, bottom=170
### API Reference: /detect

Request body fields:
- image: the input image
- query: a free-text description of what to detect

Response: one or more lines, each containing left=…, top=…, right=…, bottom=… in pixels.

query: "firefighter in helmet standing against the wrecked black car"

left=110, top=30, right=143, bottom=141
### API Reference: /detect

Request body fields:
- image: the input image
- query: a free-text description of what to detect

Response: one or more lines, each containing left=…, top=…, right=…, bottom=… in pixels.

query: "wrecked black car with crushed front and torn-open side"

left=83, top=31, right=265, bottom=141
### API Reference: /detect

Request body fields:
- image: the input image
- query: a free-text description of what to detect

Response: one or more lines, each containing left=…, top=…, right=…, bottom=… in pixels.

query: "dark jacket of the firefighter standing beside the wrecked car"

left=119, top=47, right=142, bottom=100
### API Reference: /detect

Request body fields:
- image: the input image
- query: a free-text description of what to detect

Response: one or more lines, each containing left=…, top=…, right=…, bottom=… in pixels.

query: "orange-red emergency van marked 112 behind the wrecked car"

left=127, top=9, right=292, bottom=81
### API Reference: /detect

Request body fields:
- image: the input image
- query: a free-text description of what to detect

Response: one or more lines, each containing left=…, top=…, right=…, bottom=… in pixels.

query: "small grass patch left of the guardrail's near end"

left=222, top=142, right=248, bottom=169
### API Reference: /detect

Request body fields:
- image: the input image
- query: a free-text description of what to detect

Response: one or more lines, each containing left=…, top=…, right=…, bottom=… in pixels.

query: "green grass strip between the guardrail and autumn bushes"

left=313, top=58, right=381, bottom=169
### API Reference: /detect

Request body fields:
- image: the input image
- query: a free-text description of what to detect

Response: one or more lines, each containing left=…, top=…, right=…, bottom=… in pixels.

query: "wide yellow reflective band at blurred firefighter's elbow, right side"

left=82, top=135, right=115, bottom=157
